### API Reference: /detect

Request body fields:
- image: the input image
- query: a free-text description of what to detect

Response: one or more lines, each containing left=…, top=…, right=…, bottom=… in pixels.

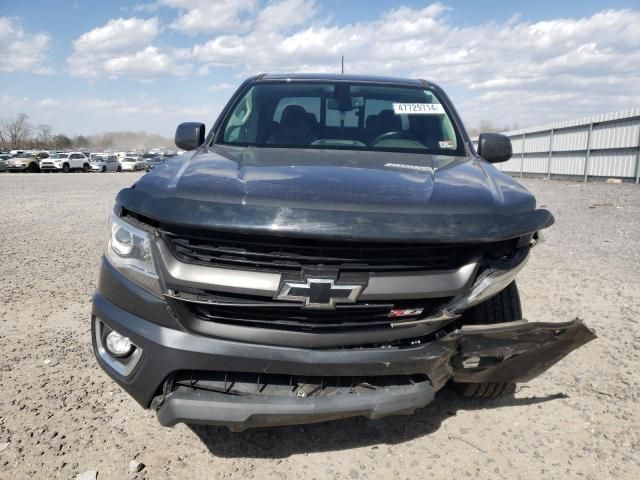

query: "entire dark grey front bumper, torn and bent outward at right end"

left=92, top=263, right=595, bottom=430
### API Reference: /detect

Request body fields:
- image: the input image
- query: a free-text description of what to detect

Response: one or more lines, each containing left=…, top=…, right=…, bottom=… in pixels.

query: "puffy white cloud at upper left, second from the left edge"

left=68, top=17, right=190, bottom=81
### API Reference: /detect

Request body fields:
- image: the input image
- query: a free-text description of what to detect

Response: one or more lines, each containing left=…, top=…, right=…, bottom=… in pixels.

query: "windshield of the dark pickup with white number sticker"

left=220, top=82, right=464, bottom=155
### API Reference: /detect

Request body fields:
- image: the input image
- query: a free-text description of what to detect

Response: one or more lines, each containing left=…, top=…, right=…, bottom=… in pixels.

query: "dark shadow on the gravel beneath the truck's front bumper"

left=189, top=387, right=568, bottom=459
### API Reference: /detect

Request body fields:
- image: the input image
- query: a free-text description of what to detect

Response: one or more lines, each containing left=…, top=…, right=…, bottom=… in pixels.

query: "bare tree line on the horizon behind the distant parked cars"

left=0, top=113, right=174, bottom=150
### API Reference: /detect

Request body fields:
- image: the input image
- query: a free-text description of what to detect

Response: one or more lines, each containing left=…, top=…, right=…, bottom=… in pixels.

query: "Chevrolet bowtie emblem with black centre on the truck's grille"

left=275, top=277, right=364, bottom=309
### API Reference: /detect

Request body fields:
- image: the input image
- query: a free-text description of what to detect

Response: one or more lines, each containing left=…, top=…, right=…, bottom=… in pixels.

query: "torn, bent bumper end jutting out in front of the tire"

left=438, top=319, right=596, bottom=383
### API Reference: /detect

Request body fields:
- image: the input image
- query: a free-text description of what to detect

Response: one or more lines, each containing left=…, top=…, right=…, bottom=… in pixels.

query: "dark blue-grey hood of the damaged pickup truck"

left=117, top=146, right=553, bottom=242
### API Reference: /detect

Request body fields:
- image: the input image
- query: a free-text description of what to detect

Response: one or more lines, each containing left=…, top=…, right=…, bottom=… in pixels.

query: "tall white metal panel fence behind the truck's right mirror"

left=473, top=108, right=640, bottom=183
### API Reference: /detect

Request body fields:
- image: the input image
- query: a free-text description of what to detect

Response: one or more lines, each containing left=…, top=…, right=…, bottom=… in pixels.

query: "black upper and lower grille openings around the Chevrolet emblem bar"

left=160, top=230, right=516, bottom=345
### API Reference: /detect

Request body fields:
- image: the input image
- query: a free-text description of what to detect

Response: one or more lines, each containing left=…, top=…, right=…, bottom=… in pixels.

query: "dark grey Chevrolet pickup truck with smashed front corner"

left=91, top=74, right=595, bottom=430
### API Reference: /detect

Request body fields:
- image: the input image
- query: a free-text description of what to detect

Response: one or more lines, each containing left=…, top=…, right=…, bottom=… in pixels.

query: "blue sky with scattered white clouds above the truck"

left=0, top=0, right=640, bottom=137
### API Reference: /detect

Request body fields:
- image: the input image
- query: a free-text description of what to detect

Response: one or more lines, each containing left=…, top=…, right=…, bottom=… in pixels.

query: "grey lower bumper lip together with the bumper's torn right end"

left=155, top=319, right=596, bottom=431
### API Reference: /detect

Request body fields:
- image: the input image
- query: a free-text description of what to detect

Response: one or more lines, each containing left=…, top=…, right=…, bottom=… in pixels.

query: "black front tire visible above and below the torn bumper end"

left=454, top=281, right=522, bottom=399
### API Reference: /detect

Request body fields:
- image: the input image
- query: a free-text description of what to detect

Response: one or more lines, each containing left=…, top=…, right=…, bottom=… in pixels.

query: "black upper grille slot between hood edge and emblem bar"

left=164, top=232, right=513, bottom=272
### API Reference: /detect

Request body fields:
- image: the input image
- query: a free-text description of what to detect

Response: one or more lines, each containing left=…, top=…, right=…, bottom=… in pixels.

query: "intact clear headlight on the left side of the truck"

left=105, top=212, right=162, bottom=297
